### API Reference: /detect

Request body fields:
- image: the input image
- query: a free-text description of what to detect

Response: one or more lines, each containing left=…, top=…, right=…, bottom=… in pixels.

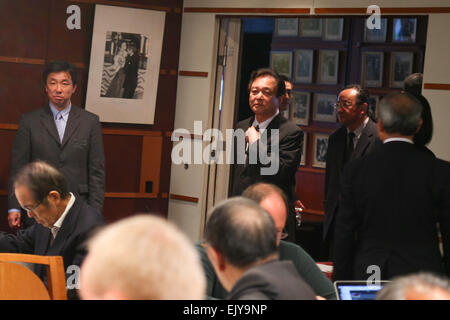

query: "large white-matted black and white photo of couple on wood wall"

left=86, top=5, right=166, bottom=124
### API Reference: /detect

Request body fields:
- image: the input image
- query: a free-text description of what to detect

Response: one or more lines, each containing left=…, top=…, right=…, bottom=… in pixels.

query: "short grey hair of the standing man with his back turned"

left=377, top=93, right=422, bottom=136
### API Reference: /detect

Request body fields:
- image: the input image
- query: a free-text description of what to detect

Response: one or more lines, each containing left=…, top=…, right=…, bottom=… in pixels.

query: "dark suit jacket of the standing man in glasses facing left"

left=323, top=120, right=381, bottom=240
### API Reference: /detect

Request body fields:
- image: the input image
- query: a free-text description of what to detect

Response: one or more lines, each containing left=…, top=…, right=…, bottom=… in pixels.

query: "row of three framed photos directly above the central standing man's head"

left=270, top=49, right=339, bottom=84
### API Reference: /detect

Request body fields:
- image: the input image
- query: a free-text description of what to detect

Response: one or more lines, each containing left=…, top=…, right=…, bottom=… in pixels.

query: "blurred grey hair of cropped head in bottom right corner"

left=376, top=272, right=450, bottom=300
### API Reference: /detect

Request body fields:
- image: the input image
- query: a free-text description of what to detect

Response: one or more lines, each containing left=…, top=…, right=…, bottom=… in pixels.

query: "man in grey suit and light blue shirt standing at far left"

left=8, top=61, right=105, bottom=228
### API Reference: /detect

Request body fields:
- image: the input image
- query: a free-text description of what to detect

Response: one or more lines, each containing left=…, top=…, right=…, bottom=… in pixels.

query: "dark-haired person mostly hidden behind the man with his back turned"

left=403, top=73, right=434, bottom=155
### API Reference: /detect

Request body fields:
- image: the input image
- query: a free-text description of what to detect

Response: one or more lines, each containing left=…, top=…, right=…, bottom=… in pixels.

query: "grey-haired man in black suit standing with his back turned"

left=334, top=93, right=450, bottom=280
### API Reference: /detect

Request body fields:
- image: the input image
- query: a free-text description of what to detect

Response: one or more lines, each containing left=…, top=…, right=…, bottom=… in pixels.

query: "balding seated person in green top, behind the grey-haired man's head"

left=196, top=183, right=336, bottom=300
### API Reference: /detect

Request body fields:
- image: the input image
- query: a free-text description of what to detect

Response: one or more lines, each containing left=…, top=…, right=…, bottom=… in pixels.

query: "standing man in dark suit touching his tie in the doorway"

left=231, top=69, right=303, bottom=242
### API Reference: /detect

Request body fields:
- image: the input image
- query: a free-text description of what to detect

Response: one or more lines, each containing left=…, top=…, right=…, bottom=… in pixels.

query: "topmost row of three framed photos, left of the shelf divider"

left=275, top=17, right=344, bottom=41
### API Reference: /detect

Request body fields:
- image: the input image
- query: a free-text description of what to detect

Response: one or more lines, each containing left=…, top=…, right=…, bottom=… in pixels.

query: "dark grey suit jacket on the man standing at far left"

left=9, top=104, right=105, bottom=212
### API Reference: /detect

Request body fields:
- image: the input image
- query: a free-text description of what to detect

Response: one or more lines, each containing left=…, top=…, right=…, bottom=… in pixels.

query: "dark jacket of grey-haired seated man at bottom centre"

left=228, top=260, right=316, bottom=300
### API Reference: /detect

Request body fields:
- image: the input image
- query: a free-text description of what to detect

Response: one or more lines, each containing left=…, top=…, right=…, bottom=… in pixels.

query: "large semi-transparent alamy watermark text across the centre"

left=171, top=121, right=280, bottom=175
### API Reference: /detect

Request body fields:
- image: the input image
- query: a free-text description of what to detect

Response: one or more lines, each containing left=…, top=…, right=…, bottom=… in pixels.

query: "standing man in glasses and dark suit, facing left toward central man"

left=322, top=85, right=380, bottom=260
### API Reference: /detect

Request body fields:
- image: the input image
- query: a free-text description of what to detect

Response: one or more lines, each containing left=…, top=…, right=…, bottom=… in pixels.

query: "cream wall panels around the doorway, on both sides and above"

left=169, top=0, right=450, bottom=240
